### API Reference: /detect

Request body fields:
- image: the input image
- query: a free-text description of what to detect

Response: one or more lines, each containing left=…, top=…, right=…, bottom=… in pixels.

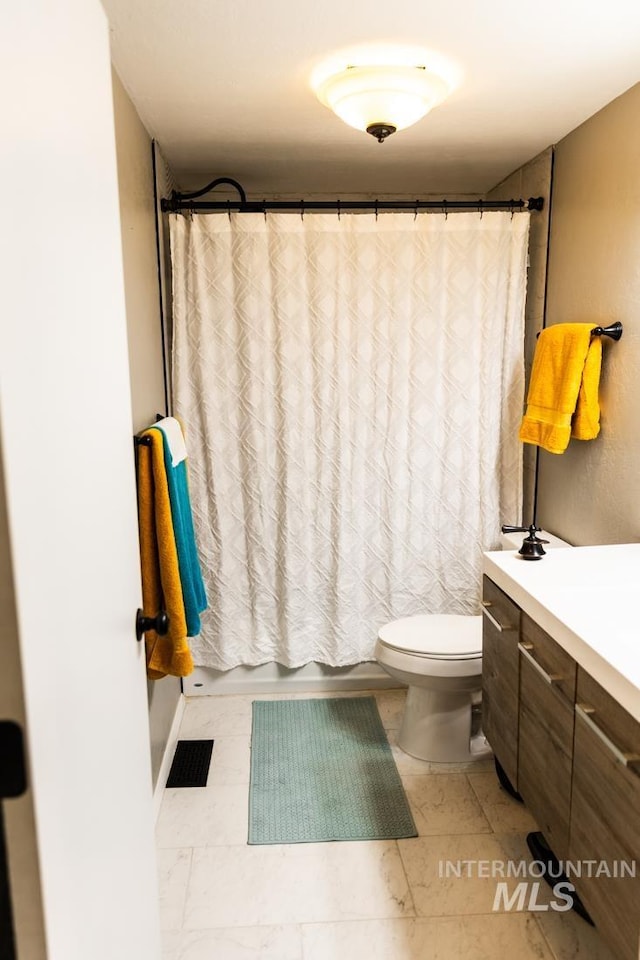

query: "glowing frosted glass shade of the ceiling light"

left=316, top=64, right=450, bottom=138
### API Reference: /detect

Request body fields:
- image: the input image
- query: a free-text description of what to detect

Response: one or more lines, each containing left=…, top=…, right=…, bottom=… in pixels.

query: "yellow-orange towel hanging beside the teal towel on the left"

left=138, top=430, right=193, bottom=680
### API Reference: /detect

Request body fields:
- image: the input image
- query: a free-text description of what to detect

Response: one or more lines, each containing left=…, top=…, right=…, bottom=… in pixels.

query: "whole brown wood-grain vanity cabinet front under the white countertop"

left=482, top=576, right=640, bottom=960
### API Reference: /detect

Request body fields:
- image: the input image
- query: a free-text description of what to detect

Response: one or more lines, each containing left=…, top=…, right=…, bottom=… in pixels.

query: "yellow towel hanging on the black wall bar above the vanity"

left=520, top=323, right=602, bottom=453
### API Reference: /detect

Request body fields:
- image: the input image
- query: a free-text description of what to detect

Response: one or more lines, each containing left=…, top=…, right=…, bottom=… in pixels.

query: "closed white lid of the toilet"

left=378, top=614, right=482, bottom=660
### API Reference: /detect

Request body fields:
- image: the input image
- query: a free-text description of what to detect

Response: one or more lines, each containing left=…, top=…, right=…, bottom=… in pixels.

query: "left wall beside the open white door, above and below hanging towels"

left=113, top=72, right=181, bottom=785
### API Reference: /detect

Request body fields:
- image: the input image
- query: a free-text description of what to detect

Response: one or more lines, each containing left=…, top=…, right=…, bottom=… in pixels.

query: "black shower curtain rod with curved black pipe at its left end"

left=160, top=177, right=544, bottom=213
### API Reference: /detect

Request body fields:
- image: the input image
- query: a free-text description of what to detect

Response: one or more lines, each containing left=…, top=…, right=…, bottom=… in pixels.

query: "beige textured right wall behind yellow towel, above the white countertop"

left=539, top=84, right=640, bottom=545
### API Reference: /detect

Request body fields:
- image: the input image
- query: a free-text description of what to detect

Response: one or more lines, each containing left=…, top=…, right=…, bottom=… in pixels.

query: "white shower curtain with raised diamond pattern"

left=171, top=213, right=529, bottom=670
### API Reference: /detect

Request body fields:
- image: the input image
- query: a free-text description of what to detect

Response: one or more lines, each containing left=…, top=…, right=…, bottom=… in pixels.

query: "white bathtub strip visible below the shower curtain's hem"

left=183, top=661, right=399, bottom=697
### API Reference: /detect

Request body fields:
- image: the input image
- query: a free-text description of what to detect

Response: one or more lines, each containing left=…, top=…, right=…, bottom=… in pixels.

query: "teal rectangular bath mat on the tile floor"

left=249, top=697, right=418, bottom=844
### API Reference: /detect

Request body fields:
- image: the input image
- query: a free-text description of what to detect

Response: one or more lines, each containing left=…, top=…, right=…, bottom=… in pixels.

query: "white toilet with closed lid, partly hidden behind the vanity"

left=375, top=532, right=569, bottom=763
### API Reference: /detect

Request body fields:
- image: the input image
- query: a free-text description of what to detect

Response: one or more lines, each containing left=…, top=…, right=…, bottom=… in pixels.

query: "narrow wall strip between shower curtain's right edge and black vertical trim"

left=487, top=147, right=553, bottom=524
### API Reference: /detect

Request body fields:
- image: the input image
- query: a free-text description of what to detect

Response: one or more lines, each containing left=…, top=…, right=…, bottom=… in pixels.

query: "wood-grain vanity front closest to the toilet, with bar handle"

left=482, top=577, right=520, bottom=789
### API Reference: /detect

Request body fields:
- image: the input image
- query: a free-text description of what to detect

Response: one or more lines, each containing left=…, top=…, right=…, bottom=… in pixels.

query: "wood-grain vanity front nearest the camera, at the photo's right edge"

left=569, top=670, right=640, bottom=960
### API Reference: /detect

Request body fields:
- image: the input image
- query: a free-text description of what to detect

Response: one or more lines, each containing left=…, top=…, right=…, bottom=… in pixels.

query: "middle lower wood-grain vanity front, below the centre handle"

left=518, top=655, right=574, bottom=859
